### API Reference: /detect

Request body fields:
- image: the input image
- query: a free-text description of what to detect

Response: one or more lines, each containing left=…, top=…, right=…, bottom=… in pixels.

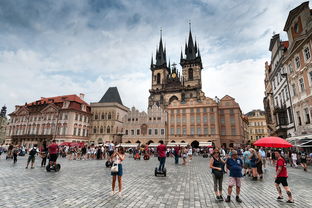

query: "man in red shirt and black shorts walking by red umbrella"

left=274, top=150, right=294, bottom=203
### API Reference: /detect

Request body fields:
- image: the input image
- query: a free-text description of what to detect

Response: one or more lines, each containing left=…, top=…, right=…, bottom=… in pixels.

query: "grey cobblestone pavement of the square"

left=0, top=155, right=312, bottom=208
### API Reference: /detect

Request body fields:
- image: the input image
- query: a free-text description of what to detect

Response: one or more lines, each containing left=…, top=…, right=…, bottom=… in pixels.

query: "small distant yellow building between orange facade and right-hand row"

left=245, top=110, right=268, bottom=143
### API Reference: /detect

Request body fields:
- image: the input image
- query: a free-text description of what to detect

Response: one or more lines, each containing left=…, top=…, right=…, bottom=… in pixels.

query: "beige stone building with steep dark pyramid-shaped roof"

left=90, top=87, right=129, bottom=144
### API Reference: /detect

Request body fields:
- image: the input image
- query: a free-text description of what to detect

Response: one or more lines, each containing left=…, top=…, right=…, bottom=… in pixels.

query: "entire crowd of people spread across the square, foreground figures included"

left=0, top=141, right=312, bottom=203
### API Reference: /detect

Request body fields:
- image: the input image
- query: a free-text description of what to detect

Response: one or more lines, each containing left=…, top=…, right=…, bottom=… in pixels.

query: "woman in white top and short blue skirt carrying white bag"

left=111, top=146, right=125, bottom=197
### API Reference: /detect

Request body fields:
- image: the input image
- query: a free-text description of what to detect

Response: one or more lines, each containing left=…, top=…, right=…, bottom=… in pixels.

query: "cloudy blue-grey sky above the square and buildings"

left=0, top=0, right=303, bottom=113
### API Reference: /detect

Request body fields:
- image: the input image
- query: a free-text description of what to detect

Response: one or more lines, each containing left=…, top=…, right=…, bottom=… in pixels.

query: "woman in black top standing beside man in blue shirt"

left=210, top=149, right=225, bottom=201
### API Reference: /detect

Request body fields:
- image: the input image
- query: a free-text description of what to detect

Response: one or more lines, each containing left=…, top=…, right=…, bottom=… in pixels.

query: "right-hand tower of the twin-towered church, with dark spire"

left=180, top=27, right=203, bottom=93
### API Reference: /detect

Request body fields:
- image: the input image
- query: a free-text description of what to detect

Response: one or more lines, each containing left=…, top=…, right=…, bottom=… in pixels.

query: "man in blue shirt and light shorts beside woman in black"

left=225, top=150, right=243, bottom=203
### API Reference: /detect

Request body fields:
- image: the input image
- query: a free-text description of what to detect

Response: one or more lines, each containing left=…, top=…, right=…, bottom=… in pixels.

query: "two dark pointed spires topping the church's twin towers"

left=151, top=24, right=202, bottom=71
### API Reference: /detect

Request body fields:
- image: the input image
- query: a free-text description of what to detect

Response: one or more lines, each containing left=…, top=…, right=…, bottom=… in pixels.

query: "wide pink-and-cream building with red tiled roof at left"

left=7, top=94, right=91, bottom=147
